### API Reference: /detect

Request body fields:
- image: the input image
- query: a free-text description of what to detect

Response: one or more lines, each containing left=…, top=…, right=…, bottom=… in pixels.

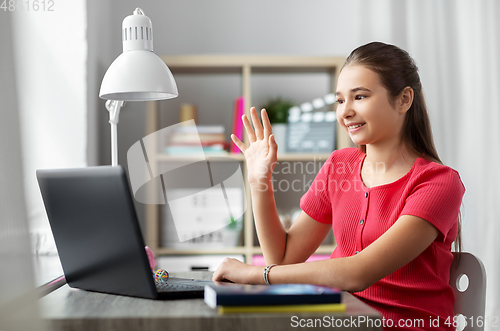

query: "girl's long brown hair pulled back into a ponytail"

left=342, top=42, right=462, bottom=252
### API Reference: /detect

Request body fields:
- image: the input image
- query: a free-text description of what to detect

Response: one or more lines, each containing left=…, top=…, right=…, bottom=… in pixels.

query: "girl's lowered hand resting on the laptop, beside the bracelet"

left=212, top=258, right=264, bottom=284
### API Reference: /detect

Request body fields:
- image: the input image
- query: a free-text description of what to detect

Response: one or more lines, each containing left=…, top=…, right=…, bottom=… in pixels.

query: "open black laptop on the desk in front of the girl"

left=36, top=166, right=213, bottom=299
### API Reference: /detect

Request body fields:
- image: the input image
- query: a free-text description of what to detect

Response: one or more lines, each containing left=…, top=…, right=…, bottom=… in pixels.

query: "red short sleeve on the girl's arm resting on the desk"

left=401, top=164, right=465, bottom=242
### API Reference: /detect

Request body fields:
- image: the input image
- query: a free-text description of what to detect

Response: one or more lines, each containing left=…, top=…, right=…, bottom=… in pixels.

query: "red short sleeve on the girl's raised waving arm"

left=300, top=151, right=337, bottom=224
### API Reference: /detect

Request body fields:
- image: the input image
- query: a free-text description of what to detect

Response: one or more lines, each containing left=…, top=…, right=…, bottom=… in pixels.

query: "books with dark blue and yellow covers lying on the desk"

left=204, top=283, right=345, bottom=314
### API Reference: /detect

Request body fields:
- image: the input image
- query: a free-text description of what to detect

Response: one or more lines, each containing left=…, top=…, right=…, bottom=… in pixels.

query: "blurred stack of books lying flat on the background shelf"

left=164, top=125, right=228, bottom=155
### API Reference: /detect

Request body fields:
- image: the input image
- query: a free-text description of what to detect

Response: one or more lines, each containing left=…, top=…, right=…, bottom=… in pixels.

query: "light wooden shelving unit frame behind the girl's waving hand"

left=146, top=55, right=350, bottom=263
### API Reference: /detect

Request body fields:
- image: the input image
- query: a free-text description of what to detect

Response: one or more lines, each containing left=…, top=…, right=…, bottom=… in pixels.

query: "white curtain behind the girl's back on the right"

left=356, top=0, right=500, bottom=330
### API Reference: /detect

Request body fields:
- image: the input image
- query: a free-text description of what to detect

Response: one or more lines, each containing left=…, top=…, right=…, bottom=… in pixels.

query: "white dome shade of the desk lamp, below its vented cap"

left=99, top=50, right=179, bottom=101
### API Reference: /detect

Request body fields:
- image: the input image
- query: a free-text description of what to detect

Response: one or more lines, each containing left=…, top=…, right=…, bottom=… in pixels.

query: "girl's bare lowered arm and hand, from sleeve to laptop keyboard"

left=213, top=215, right=439, bottom=292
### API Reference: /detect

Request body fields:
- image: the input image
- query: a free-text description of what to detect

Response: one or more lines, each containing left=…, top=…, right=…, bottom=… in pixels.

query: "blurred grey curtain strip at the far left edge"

left=0, top=11, right=41, bottom=330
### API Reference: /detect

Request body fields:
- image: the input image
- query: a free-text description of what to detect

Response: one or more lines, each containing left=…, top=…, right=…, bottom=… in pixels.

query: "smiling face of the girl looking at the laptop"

left=336, top=65, right=407, bottom=146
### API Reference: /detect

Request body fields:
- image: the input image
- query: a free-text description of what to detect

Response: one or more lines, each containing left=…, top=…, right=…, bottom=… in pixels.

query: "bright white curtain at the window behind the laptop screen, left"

left=9, top=0, right=87, bottom=254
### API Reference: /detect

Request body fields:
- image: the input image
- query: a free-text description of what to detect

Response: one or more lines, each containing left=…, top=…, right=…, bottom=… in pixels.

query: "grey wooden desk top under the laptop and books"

left=40, top=272, right=382, bottom=331
